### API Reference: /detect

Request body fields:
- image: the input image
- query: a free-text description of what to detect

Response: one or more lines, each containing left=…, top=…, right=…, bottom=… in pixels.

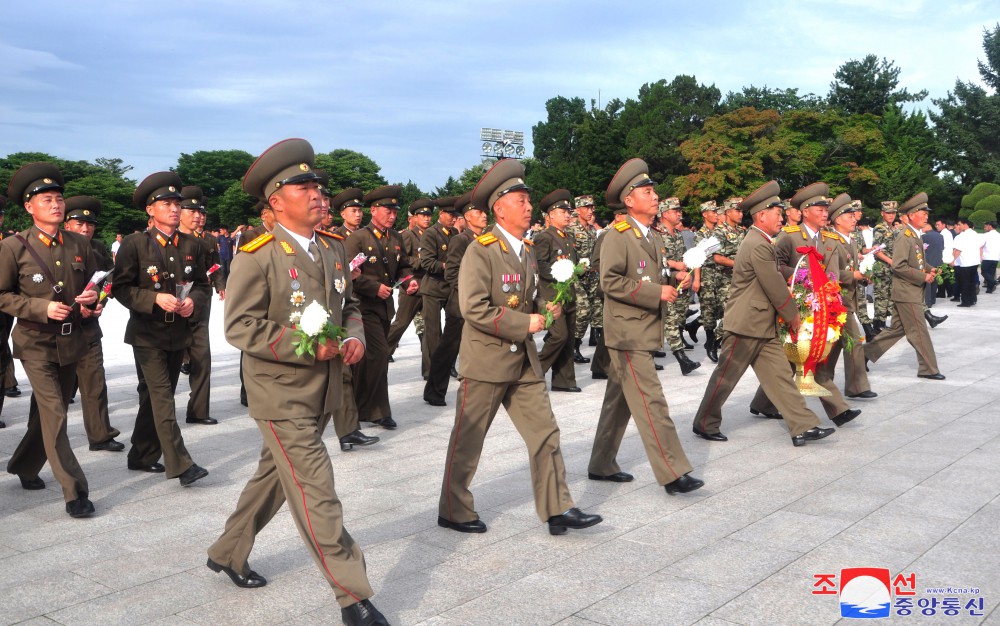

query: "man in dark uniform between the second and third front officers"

left=531, top=189, right=580, bottom=392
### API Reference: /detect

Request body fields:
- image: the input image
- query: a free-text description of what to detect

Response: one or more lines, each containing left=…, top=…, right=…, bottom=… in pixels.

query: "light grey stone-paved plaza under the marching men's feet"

left=0, top=294, right=1000, bottom=626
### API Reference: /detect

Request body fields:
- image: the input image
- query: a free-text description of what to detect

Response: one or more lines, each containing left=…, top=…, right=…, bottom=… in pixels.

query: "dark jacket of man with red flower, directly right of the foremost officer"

left=344, top=224, right=413, bottom=320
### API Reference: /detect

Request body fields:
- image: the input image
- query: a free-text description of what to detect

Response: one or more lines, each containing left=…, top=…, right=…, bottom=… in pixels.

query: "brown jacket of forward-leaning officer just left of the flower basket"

left=723, top=227, right=798, bottom=339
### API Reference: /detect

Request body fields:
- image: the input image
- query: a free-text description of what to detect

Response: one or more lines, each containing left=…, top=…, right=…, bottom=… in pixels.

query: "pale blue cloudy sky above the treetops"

left=0, top=0, right=1000, bottom=191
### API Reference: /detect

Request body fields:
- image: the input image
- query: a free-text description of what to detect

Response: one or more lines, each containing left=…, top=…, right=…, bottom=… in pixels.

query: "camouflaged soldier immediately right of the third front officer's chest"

left=654, top=198, right=701, bottom=376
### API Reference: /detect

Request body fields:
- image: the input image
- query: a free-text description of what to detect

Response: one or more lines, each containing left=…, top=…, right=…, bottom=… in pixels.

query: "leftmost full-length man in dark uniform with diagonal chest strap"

left=0, top=163, right=97, bottom=517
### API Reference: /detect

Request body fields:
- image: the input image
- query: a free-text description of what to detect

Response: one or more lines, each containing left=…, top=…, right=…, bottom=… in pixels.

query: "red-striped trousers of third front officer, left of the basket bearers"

left=588, top=348, right=692, bottom=485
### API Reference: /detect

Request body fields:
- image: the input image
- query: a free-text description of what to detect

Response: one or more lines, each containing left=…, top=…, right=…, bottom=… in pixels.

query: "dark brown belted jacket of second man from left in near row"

left=111, top=229, right=212, bottom=351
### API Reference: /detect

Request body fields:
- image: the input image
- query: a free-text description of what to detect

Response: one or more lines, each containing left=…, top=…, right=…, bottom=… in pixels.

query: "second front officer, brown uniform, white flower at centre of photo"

left=438, top=159, right=602, bottom=535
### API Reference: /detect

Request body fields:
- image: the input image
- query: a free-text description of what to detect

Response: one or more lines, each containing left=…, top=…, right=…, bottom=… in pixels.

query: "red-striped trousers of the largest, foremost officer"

left=208, top=416, right=374, bottom=607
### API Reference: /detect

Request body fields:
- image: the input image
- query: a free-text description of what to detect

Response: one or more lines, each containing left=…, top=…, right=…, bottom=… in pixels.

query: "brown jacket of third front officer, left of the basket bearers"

left=598, top=217, right=663, bottom=350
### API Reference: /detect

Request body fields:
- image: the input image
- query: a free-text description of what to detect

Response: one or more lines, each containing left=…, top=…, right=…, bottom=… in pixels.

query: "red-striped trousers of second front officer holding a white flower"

left=438, top=358, right=574, bottom=522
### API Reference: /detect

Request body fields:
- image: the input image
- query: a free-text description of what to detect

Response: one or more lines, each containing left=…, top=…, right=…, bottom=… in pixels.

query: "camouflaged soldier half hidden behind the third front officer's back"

left=566, top=196, right=604, bottom=363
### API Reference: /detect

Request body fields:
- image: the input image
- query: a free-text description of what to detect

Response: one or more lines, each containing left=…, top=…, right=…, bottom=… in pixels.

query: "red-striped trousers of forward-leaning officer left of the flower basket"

left=694, top=332, right=819, bottom=437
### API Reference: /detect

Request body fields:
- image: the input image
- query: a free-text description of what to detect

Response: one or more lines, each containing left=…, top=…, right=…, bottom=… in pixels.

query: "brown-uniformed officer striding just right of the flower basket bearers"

left=816, top=193, right=878, bottom=398
